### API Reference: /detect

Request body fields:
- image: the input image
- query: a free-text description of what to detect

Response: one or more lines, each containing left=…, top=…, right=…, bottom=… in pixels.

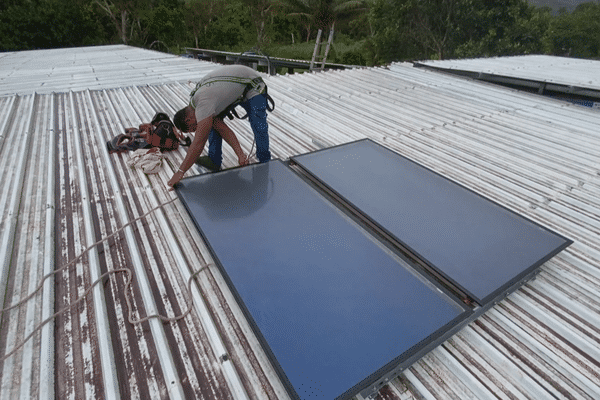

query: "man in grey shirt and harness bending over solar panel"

left=168, top=65, right=271, bottom=187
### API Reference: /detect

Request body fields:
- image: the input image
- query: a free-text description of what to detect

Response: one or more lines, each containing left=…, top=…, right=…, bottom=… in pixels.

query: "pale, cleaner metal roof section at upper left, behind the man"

left=0, top=45, right=218, bottom=95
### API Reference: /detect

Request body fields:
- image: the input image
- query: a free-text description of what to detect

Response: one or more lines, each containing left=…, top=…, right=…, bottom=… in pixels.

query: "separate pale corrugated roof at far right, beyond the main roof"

left=419, top=55, right=600, bottom=90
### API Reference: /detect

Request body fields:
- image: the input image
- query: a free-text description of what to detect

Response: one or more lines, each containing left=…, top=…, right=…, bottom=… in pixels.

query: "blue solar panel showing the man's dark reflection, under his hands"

left=177, top=161, right=470, bottom=399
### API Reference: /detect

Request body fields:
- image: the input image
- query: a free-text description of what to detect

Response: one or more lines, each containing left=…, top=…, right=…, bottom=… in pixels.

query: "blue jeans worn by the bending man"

left=208, top=94, right=271, bottom=167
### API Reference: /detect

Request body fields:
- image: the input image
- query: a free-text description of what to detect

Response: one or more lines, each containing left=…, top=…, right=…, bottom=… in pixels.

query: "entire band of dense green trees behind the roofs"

left=0, top=0, right=600, bottom=64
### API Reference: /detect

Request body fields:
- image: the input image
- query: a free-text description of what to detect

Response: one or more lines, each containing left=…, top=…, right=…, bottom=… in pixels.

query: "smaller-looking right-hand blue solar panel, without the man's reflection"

left=294, top=140, right=571, bottom=304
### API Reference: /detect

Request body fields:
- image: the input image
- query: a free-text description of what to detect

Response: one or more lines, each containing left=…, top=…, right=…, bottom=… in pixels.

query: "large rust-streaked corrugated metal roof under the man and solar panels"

left=0, top=47, right=600, bottom=399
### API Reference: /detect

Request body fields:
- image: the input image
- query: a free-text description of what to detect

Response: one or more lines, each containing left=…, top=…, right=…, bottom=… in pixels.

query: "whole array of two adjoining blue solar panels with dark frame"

left=177, top=139, right=572, bottom=399
